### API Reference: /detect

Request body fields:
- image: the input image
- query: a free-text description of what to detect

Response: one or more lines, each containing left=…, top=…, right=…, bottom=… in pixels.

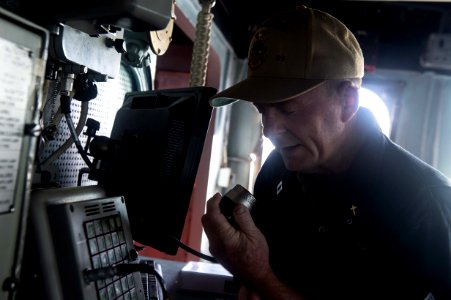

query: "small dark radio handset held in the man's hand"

left=219, top=184, right=256, bottom=228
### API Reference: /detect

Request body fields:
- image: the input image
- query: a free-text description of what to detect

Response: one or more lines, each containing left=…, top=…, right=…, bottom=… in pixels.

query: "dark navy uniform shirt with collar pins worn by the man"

left=252, top=108, right=451, bottom=300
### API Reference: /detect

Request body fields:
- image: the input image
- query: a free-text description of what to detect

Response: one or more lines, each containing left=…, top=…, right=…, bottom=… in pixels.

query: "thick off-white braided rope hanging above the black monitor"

left=189, top=0, right=215, bottom=86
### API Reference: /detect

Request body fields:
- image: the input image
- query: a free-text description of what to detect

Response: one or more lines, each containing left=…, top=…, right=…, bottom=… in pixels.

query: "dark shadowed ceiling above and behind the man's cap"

left=212, top=0, right=451, bottom=70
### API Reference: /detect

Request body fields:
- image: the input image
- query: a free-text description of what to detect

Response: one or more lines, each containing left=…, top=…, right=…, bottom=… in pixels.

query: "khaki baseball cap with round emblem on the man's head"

left=210, top=6, right=364, bottom=107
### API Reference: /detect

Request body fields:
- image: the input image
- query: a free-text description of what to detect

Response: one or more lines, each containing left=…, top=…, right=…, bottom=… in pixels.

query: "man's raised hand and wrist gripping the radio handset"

left=202, top=194, right=305, bottom=300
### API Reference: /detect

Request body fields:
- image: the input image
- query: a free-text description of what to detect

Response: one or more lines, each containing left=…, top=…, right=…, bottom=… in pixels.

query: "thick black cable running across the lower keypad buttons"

left=83, top=264, right=169, bottom=300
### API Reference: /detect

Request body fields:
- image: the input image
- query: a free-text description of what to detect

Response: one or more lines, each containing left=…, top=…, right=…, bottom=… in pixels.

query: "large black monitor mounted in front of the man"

left=99, top=87, right=216, bottom=255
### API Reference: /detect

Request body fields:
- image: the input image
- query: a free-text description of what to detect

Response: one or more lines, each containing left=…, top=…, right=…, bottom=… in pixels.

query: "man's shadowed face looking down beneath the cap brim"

left=255, top=86, right=344, bottom=172
